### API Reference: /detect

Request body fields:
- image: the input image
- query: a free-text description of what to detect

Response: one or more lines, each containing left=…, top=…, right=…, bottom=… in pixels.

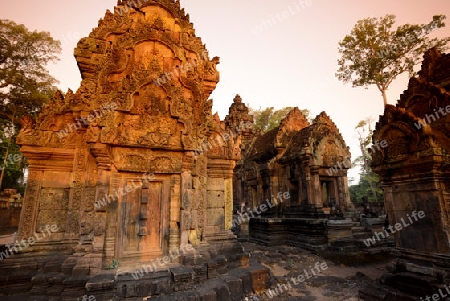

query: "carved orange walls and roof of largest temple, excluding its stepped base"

left=17, top=0, right=244, bottom=282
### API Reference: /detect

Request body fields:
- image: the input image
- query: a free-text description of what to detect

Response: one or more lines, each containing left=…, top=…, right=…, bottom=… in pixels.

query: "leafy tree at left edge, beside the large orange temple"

left=0, top=20, right=61, bottom=187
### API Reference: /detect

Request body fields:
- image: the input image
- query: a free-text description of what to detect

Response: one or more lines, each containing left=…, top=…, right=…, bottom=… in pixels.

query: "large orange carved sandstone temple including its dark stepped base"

left=0, top=0, right=267, bottom=300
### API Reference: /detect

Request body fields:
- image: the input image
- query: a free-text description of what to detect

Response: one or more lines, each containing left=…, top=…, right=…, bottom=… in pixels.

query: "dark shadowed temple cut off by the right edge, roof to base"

left=360, top=48, right=450, bottom=301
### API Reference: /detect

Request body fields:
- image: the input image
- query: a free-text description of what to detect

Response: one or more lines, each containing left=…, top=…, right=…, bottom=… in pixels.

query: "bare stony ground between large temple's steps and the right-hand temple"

left=243, top=242, right=391, bottom=301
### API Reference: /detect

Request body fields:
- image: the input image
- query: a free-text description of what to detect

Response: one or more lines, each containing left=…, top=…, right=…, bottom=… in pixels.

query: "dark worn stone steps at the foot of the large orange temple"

left=0, top=251, right=269, bottom=301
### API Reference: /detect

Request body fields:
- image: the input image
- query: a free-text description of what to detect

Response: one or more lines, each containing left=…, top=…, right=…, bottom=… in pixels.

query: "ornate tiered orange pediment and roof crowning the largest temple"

left=19, top=0, right=220, bottom=150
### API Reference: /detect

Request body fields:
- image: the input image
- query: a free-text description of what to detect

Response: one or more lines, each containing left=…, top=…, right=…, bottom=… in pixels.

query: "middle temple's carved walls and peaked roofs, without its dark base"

left=233, top=108, right=353, bottom=217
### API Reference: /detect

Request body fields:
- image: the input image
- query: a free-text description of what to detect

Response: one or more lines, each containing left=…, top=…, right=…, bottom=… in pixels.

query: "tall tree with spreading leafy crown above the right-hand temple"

left=336, top=15, right=450, bottom=106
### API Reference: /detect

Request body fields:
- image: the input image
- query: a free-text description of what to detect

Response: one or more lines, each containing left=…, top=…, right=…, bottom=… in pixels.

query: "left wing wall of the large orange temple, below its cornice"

left=18, top=146, right=75, bottom=248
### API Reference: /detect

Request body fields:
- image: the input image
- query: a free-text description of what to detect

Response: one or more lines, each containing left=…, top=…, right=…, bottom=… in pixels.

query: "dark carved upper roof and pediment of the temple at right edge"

left=372, top=48, right=450, bottom=167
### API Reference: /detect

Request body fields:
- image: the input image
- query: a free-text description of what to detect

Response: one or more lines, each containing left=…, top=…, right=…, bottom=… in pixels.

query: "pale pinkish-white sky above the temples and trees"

left=0, top=0, right=450, bottom=183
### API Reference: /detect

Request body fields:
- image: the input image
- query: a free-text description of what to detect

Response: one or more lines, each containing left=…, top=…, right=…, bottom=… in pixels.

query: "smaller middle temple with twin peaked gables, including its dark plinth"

left=233, top=108, right=371, bottom=252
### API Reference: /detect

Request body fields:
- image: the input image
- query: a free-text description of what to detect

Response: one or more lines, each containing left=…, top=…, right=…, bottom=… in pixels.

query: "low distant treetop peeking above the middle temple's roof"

left=250, top=107, right=310, bottom=133
